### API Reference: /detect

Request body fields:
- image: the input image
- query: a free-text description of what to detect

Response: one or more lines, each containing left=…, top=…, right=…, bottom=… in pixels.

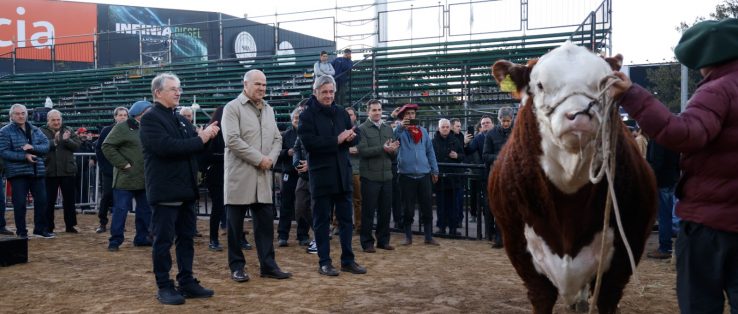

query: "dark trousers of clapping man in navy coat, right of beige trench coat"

left=313, top=191, right=354, bottom=266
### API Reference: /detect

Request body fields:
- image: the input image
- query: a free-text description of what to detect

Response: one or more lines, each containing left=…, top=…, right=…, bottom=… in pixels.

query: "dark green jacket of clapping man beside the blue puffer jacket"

left=40, top=125, right=82, bottom=177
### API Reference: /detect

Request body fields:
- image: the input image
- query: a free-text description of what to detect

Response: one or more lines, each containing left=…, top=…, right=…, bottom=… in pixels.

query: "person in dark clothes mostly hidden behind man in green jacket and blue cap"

left=95, top=107, right=128, bottom=233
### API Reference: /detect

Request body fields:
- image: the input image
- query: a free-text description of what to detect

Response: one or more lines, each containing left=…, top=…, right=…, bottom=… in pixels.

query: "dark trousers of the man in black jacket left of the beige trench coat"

left=151, top=201, right=197, bottom=289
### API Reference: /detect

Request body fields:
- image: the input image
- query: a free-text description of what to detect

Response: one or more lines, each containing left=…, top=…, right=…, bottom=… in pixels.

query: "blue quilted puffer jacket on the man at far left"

left=0, top=122, right=49, bottom=179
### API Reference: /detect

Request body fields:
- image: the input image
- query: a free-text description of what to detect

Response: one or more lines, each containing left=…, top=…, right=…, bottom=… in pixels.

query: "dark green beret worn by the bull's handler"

left=674, top=18, right=738, bottom=70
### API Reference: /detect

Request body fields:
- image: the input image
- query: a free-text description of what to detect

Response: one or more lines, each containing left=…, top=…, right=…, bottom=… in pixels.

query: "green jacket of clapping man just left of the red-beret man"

left=358, top=119, right=393, bottom=182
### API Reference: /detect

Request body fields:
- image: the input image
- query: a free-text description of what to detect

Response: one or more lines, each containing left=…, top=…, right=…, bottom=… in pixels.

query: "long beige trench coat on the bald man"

left=221, top=93, right=282, bottom=205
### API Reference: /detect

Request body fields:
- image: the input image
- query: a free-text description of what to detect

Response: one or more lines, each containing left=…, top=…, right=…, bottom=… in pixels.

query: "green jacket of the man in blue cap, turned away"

left=102, top=118, right=145, bottom=191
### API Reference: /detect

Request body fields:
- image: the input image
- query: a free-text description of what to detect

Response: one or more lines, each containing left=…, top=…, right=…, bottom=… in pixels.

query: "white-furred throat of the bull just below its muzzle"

left=541, top=141, right=594, bottom=194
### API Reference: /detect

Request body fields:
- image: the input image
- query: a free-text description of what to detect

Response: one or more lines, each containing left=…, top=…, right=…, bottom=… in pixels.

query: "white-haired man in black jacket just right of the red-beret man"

left=432, top=119, right=464, bottom=236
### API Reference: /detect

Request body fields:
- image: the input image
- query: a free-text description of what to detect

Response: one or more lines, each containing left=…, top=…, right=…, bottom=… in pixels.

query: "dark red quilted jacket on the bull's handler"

left=620, top=60, right=738, bottom=232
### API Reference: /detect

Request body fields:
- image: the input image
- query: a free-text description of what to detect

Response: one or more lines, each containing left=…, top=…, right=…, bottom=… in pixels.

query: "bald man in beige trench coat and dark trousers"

left=222, top=70, right=292, bottom=282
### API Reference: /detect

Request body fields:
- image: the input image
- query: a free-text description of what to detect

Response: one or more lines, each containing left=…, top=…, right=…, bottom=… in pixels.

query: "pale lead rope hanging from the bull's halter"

left=589, top=75, right=640, bottom=314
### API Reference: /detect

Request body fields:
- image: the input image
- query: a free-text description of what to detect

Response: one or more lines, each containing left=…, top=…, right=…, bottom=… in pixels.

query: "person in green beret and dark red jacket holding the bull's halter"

left=611, top=18, right=738, bottom=313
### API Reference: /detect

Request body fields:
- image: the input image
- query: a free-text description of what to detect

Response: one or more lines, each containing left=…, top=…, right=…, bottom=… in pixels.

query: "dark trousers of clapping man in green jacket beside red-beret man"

left=359, top=177, right=392, bottom=248
